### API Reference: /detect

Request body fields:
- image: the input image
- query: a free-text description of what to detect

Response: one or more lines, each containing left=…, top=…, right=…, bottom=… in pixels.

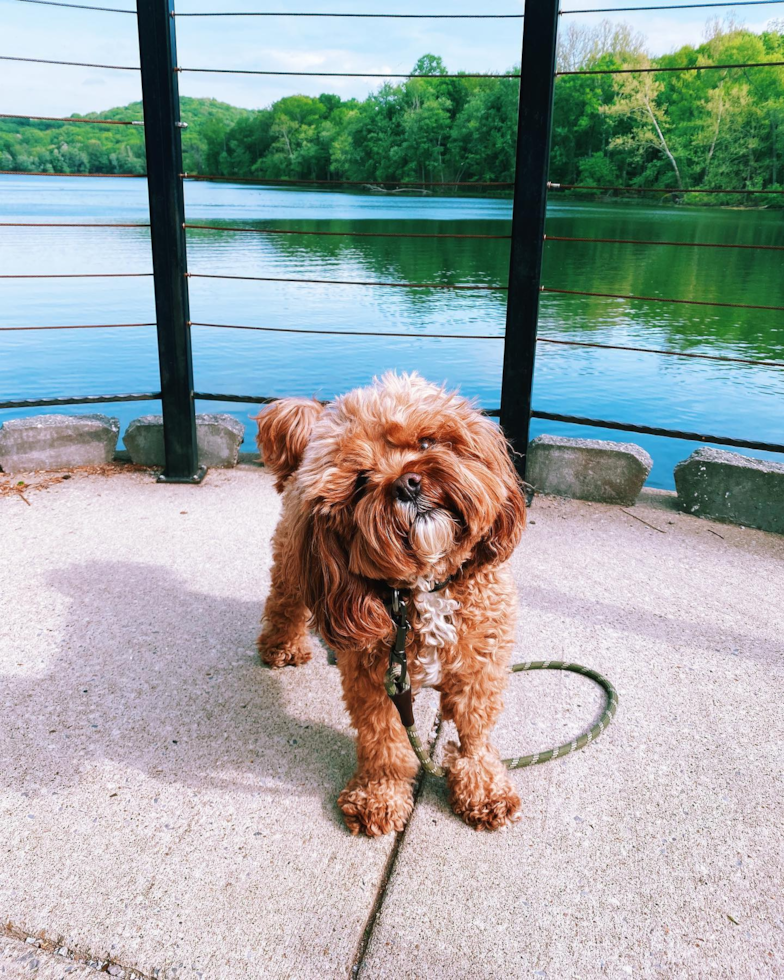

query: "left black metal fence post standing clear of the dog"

left=136, top=0, right=205, bottom=483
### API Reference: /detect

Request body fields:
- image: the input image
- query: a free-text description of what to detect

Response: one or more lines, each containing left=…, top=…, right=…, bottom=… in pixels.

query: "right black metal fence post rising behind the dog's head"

left=501, top=0, right=558, bottom=476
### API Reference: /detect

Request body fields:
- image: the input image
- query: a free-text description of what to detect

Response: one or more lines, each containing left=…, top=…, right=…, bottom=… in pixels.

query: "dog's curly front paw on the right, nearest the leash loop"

left=445, top=743, right=521, bottom=830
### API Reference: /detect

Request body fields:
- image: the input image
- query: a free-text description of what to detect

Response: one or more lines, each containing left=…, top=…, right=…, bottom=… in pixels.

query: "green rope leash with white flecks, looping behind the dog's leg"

left=384, top=582, right=618, bottom=776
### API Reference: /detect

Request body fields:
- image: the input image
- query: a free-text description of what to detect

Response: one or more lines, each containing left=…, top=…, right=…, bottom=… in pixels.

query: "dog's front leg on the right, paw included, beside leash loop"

left=441, top=657, right=520, bottom=830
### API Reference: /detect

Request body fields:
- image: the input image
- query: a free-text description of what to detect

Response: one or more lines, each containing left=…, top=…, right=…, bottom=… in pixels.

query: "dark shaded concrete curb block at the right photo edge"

left=675, top=447, right=784, bottom=534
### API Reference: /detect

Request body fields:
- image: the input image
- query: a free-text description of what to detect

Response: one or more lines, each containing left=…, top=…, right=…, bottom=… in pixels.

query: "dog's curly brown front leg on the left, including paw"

left=338, top=651, right=419, bottom=837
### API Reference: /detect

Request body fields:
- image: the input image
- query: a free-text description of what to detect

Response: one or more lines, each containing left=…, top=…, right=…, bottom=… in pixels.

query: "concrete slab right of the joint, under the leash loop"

left=360, top=495, right=784, bottom=980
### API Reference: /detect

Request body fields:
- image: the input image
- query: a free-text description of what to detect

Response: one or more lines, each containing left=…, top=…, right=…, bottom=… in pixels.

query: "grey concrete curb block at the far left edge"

left=0, top=415, right=120, bottom=473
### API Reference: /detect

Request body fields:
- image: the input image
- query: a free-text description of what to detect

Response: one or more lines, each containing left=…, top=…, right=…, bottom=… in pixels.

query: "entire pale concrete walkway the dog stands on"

left=0, top=466, right=784, bottom=980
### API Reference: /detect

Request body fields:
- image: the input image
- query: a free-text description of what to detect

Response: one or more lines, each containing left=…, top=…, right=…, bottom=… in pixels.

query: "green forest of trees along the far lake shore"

left=0, top=20, right=784, bottom=207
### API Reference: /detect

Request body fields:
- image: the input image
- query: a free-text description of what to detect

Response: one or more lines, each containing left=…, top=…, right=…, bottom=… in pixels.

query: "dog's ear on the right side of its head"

left=471, top=419, right=526, bottom=568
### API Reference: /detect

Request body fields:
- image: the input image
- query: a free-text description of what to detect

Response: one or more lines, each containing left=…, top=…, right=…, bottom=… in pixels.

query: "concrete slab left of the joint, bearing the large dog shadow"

left=0, top=467, right=438, bottom=980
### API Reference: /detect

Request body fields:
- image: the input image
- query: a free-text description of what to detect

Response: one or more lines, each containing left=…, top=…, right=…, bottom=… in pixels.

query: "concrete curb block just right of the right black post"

left=526, top=435, right=653, bottom=505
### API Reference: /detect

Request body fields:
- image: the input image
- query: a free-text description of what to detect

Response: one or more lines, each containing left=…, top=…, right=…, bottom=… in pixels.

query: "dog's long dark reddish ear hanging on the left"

left=299, top=512, right=394, bottom=651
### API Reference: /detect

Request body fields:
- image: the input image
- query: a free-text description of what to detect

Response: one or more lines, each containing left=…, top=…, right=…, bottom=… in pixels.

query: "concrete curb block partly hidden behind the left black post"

left=123, top=415, right=245, bottom=467
